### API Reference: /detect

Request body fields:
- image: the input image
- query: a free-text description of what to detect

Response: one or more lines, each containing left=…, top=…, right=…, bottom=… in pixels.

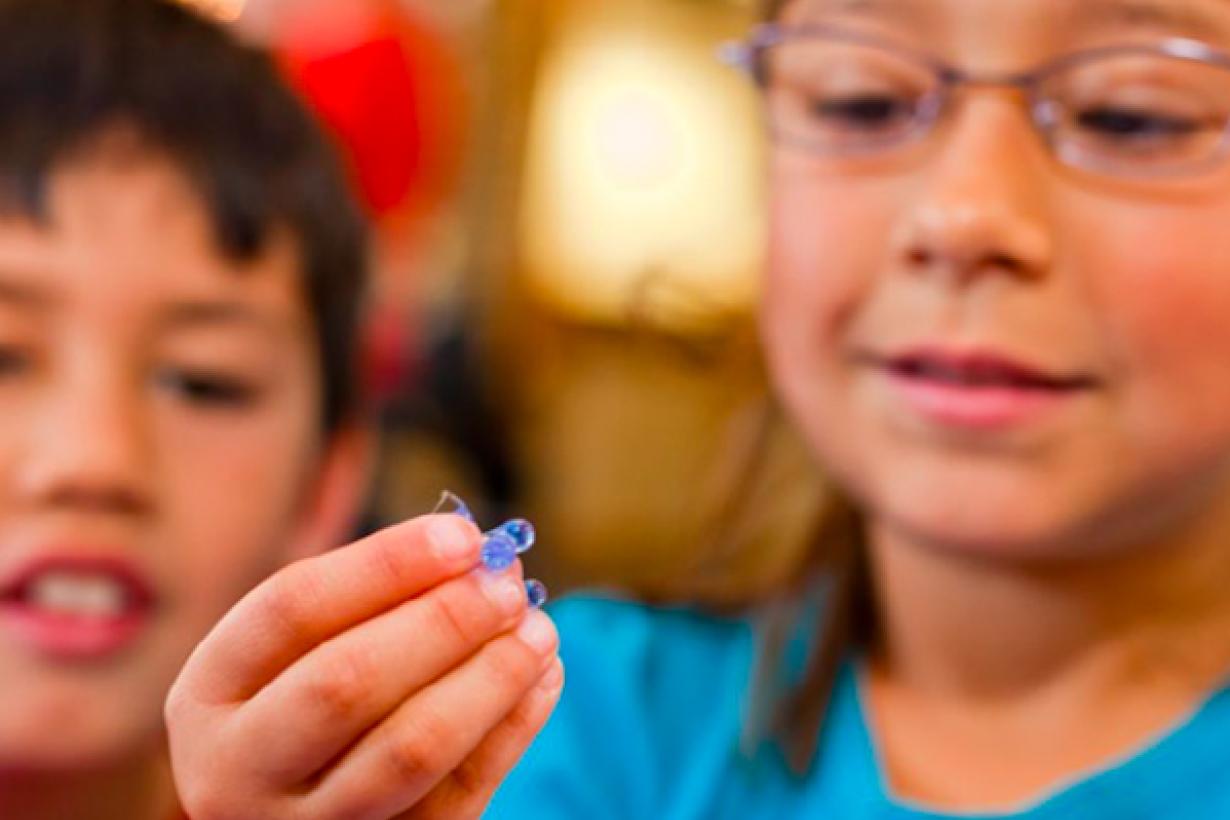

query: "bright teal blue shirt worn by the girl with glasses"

left=485, top=599, right=1230, bottom=820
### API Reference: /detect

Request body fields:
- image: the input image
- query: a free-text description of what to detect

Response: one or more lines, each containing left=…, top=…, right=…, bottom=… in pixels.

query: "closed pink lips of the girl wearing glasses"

left=866, top=348, right=1097, bottom=430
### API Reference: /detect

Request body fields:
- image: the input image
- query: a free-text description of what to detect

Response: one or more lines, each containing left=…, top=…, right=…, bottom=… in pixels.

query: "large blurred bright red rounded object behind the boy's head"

left=273, top=0, right=467, bottom=220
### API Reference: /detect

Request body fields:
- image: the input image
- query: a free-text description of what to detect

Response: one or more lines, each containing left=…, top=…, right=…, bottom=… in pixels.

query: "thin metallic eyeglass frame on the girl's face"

left=718, top=23, right=1230, bottom=177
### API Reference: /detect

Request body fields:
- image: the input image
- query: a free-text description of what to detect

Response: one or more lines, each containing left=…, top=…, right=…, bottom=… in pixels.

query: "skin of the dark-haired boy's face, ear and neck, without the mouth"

left=0, top=147, right=365, bottom=819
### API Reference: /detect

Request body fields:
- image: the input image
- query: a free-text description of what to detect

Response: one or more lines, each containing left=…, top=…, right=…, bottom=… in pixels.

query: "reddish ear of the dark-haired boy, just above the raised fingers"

left=285, top=423, right=376, bottom=563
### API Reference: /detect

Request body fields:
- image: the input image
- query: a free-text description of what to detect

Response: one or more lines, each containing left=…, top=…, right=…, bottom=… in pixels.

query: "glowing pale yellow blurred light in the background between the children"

left=522, top=2, right=764, bottom=326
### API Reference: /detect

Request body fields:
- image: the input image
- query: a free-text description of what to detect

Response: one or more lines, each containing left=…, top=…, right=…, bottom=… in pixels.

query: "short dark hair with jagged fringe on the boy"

left=0, top=0, right=367, bottom=432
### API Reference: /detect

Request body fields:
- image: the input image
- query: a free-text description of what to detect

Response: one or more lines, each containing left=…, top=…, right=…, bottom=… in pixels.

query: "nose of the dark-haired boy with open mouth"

left=17, top=377, right=151, bottom=515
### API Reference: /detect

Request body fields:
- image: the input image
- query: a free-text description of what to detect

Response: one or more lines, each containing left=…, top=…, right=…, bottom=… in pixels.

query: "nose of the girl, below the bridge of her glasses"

left=893, top=97, right=1053, bottom=284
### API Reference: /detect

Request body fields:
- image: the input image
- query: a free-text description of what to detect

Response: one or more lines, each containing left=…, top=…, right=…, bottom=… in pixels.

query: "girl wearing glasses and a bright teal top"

left=172, top=0, right=1230, bottom=820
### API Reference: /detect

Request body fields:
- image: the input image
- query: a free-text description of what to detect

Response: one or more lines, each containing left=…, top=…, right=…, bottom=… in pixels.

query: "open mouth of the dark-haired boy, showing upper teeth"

left=0, top=557, right=154, bottom=660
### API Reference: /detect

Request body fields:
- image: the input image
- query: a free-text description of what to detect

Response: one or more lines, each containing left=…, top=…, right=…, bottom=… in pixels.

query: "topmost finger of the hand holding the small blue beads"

left=181, top=514, right=482, bottom=703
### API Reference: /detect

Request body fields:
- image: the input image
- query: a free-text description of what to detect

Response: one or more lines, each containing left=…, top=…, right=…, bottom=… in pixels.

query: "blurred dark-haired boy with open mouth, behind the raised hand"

left=0, top=0, right=365, bottom=820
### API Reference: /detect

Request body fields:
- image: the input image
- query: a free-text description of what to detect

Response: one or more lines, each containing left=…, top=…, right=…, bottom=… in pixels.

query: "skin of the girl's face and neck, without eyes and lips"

left=763, top=0, right=1230, bottom=810
